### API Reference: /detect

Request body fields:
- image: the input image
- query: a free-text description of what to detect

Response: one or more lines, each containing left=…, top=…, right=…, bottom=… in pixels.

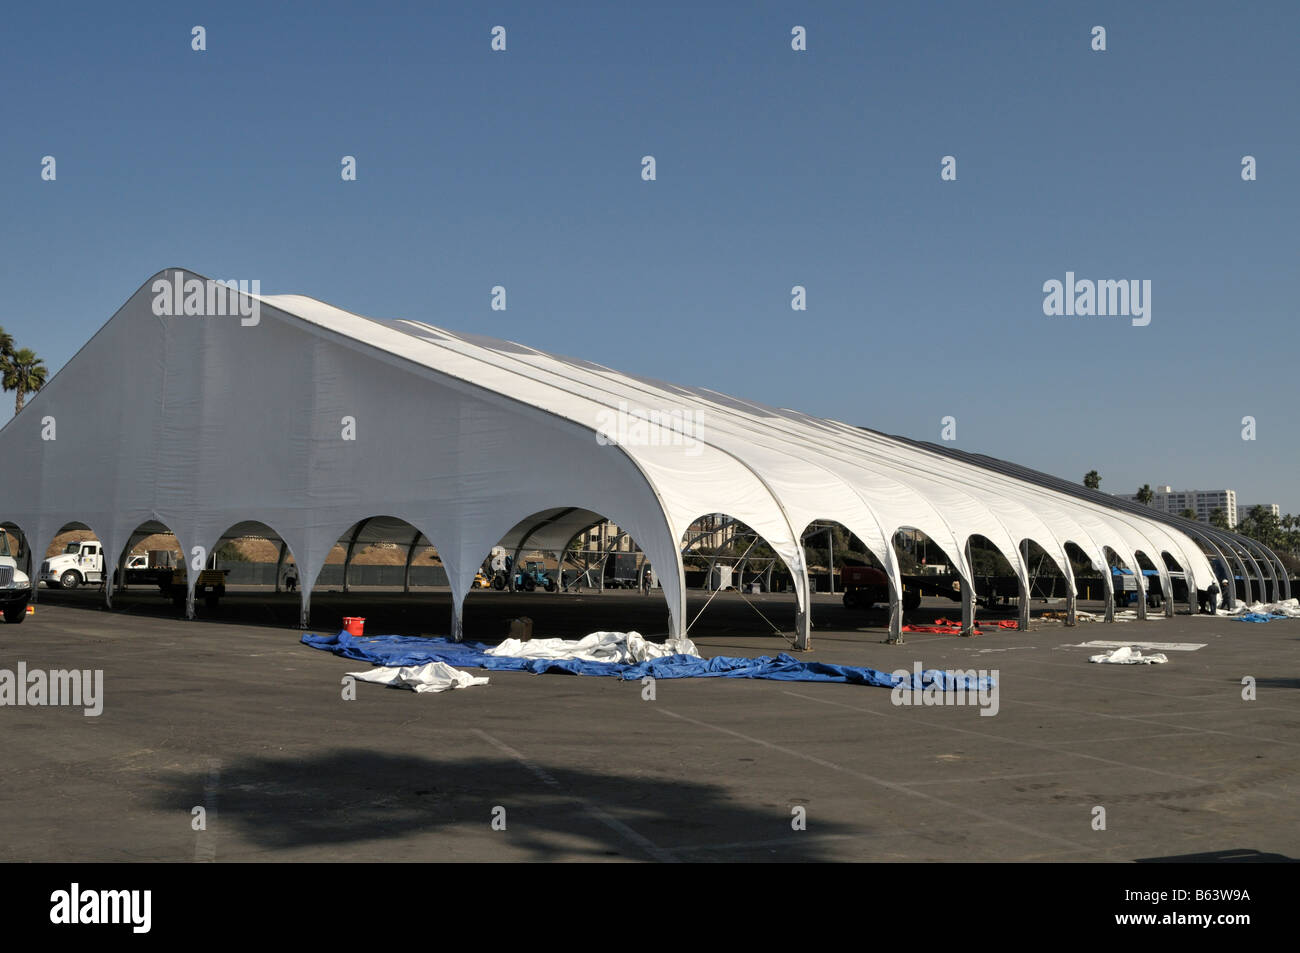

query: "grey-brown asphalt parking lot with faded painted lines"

left=0, top=590, right=1300, bottom=862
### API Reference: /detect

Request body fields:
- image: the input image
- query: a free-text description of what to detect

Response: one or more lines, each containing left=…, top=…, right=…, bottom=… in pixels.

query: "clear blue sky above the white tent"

left=0, top=0, right=1300, bottom=512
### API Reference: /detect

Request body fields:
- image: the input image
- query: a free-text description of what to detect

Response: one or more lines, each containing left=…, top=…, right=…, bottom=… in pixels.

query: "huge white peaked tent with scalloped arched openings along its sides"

left=0, top=269, right=1290, bottom=646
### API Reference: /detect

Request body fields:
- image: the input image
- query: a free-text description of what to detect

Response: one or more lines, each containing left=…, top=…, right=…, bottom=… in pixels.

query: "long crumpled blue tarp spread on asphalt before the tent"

left=303, top=632, right=993, bottom=692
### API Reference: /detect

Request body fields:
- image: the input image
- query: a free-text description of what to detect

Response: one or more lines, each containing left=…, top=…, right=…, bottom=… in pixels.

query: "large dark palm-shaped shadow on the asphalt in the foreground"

left=156, top=742, right=863, bottom=862
